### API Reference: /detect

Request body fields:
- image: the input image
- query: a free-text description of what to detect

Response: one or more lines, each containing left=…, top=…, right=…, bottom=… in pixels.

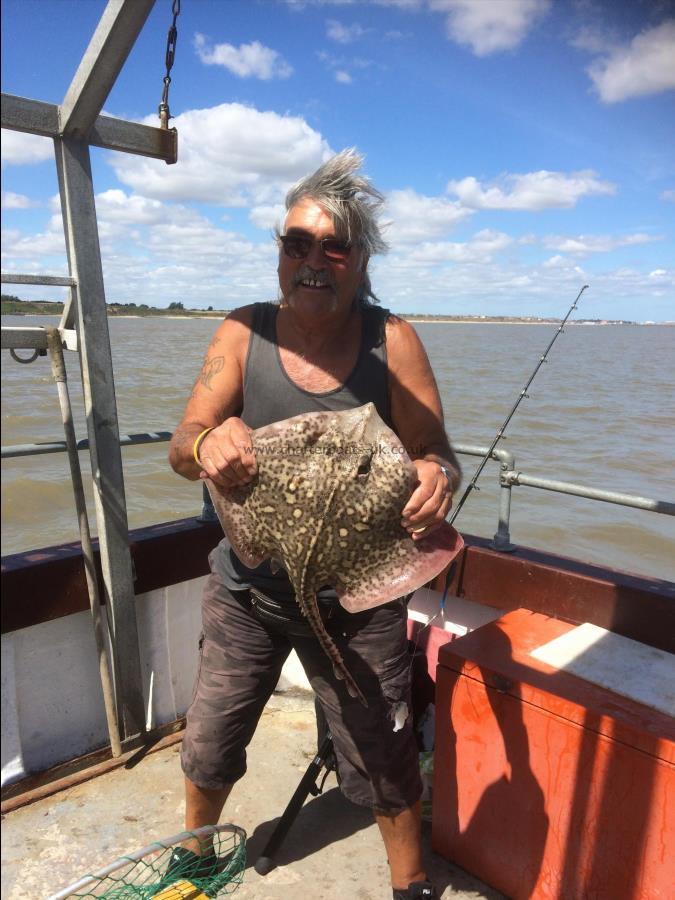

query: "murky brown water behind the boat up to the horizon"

left=2, top=316, right=675, bottom=580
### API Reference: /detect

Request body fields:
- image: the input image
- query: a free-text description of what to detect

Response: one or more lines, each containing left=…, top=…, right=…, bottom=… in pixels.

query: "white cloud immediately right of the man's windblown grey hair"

left=386, top=188, right=471, bottom=243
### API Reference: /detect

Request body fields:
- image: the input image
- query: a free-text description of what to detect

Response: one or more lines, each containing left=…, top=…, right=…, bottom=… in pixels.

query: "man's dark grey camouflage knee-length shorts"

left=181, top=574, right=422, bottom=813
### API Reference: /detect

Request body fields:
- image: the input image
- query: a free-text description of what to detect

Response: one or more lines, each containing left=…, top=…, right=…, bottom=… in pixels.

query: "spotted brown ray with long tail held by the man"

left=207, top=403, right=463, bottom=705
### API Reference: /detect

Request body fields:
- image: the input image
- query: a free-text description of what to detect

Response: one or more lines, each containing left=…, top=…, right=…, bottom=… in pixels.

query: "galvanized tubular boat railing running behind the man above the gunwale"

left=2, top=428, right=675, bottom=553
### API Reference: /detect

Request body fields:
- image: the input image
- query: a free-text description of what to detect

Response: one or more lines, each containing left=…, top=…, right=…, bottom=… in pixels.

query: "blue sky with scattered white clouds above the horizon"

left=2, top=0, right=675, bottom=322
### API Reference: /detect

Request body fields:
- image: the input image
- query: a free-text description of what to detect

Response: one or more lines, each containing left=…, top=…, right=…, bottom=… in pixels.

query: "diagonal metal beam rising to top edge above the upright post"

left=59, top=0, right=155, bottom=140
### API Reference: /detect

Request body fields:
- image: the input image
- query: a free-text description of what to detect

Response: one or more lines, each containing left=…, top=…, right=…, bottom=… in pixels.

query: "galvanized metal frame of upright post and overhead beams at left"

left=2, top=0, right=177, bottom=751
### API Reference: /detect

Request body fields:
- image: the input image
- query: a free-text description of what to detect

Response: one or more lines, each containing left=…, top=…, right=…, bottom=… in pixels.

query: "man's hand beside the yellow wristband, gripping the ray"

left=199, top=416, right=258, bottom=489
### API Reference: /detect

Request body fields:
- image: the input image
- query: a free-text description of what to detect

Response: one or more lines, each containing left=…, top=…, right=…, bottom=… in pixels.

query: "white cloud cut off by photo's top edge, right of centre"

left=429, top=0, right=551, bottom=56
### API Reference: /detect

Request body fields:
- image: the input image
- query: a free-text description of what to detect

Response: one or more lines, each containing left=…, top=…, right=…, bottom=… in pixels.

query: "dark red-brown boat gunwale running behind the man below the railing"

left=2, top=518, right=675, bottom=652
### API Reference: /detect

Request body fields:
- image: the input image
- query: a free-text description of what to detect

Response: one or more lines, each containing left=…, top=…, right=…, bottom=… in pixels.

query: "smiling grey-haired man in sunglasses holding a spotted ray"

left=170, top=150, right=460, bottom=900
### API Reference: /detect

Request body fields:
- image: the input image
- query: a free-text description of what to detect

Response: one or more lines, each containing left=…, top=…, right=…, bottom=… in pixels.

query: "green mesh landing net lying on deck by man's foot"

left=48, top=825, right=246, bottom=900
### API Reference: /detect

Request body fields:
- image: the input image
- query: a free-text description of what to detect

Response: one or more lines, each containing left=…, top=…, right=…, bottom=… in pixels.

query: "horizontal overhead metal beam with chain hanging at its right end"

left=2, top=94, right=178, bottom=163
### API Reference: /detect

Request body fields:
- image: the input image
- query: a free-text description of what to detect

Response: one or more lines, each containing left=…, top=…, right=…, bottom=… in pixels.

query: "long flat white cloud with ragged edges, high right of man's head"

left=448, top=169, right=616, bottom=210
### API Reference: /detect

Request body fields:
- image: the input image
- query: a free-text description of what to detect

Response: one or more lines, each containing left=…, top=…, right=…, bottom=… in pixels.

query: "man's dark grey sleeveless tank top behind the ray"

left=211, top=303, right=392, bottom=601
